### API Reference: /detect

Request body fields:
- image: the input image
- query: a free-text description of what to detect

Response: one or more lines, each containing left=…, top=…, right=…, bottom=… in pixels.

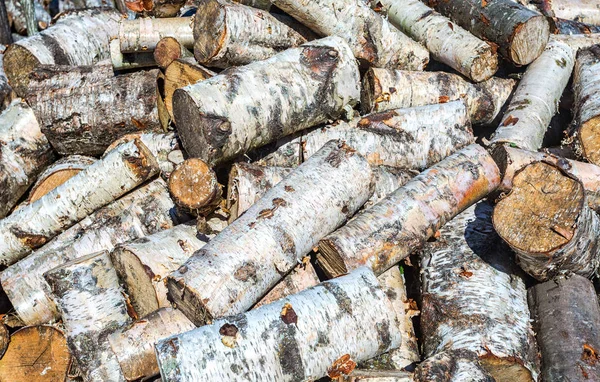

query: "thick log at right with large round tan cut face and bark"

left=494, top=162, right=600, bottom=281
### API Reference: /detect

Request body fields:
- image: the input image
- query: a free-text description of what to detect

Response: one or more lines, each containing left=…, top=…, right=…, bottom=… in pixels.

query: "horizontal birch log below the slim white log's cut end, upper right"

left=360, top=68, right=515, bottom=124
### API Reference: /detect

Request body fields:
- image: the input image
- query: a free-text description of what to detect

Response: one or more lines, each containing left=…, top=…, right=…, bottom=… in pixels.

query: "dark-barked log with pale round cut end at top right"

left=428, top=0, right=550, bottom=65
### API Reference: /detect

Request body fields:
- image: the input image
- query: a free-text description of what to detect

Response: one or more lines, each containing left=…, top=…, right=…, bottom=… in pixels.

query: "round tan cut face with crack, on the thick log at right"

left=493, top=162, right=585, bottom=254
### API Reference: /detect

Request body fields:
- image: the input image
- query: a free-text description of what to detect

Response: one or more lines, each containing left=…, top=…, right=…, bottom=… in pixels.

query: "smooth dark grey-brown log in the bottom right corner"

left=529, top=275, right=600, bottom=381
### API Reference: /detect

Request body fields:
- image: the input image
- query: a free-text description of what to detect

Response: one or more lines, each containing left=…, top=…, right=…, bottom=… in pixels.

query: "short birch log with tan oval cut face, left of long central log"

left=110, top=222, right=209, bottom=317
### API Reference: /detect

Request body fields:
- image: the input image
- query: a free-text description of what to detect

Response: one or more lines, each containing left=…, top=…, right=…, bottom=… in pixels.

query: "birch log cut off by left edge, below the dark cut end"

left=0, top=100, right=54, bottom=218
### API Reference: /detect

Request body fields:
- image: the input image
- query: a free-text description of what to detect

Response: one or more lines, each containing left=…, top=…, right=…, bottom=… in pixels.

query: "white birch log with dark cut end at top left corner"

left=4, top=9, right=121, bottom=95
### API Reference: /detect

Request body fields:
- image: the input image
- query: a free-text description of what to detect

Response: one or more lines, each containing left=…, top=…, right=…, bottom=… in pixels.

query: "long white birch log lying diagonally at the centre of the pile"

left=167, top=141, right=373, bottom=325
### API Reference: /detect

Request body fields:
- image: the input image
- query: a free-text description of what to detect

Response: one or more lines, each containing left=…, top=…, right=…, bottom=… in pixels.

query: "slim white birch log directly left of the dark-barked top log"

left=370, top=0, right=498, bottom=82
